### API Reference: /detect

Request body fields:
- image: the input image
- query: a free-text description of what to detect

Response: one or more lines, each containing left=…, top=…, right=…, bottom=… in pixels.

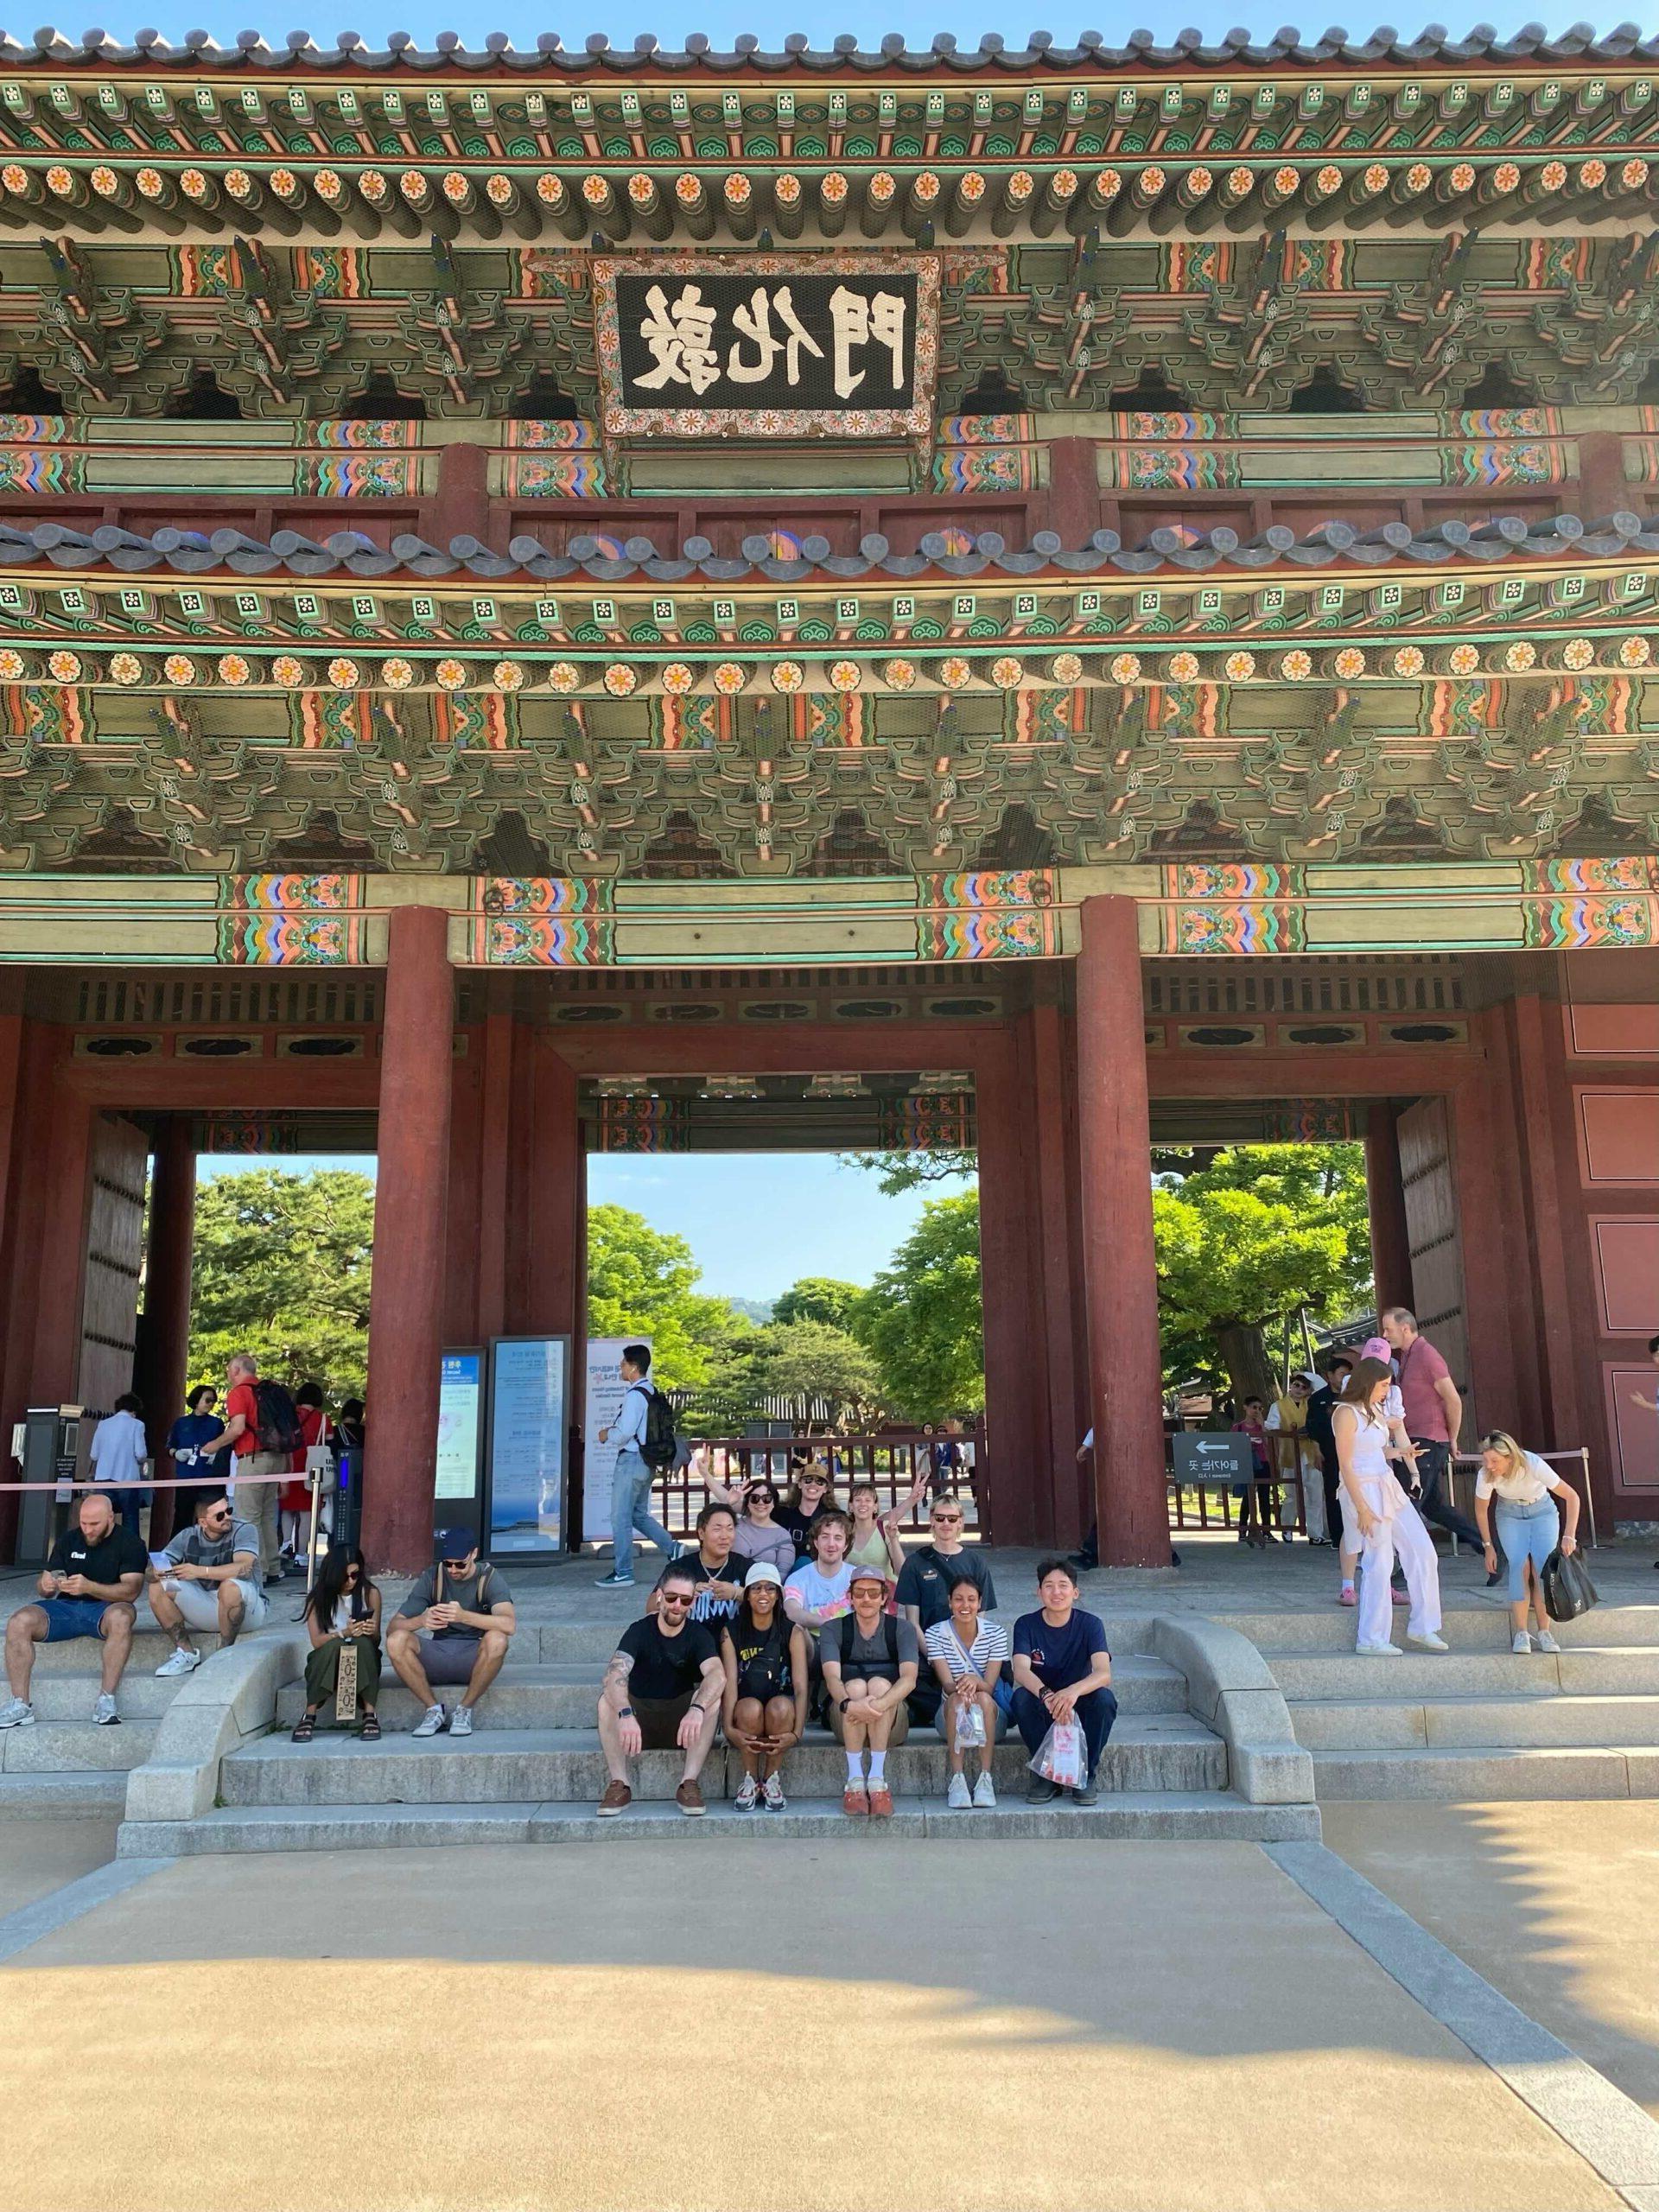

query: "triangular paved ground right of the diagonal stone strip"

left=1320, top=1798, right=1659, bottom=2119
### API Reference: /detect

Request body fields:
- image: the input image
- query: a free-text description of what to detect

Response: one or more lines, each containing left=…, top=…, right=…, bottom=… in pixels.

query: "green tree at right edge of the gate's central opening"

left=854, top=1190, right=984, bottom=1421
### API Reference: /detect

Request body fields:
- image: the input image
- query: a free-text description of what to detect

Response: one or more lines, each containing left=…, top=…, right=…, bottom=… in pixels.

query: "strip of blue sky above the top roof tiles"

left=48, top=0, right=1601, bottom=51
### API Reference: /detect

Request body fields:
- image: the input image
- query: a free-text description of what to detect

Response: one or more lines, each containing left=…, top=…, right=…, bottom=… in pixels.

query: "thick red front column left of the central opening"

left=363, top=907, right=455, bottom=1573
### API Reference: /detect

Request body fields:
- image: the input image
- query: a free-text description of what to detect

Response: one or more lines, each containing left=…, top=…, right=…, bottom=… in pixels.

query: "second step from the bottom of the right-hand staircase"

left=1289, top=1670, right=1659, bottom=1752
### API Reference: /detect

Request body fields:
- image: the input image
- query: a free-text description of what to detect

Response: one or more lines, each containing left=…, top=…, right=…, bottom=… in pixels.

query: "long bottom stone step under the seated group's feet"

left=118, top=1789, right=1319, bottom=1865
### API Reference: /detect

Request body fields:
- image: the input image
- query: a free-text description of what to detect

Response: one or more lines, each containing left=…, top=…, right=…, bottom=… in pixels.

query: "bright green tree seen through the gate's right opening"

left=1153, top=1144, right=1371, bottom=1395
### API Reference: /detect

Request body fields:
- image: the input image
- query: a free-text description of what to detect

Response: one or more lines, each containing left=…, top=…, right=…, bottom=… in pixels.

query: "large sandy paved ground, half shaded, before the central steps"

left=0, top=1840, right=1645, bottom=2212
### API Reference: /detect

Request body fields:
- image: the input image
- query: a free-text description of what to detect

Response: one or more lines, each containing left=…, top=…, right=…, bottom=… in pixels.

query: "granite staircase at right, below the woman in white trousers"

left=1225, top=1604, right=1659, bottom=1801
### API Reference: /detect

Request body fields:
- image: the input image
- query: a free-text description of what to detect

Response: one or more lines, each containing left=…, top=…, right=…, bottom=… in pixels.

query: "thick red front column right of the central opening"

left=1077, top=898, right=1170, bottom=1566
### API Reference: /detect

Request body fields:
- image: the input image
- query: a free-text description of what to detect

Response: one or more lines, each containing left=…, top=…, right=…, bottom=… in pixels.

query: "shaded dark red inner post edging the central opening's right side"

left=973, top=1028, right=1048, bottom=1544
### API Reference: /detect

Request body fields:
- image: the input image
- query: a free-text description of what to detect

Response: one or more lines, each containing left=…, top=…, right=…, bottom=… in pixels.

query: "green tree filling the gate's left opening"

left=190, top=1168, right=374, bottom=1405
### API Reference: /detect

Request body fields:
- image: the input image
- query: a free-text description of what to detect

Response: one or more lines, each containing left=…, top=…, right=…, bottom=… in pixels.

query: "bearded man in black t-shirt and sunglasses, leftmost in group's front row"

left=600, top=1566, right=726, bottom=1818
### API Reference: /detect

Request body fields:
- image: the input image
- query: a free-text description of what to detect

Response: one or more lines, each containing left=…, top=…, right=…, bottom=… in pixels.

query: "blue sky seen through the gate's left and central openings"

left=197, top=1153, right=969, bottom=1299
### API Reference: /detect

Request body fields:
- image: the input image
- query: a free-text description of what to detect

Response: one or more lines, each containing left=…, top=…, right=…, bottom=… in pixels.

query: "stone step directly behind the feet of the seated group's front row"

left=219, top=1714, right=1228, bottom=1805
